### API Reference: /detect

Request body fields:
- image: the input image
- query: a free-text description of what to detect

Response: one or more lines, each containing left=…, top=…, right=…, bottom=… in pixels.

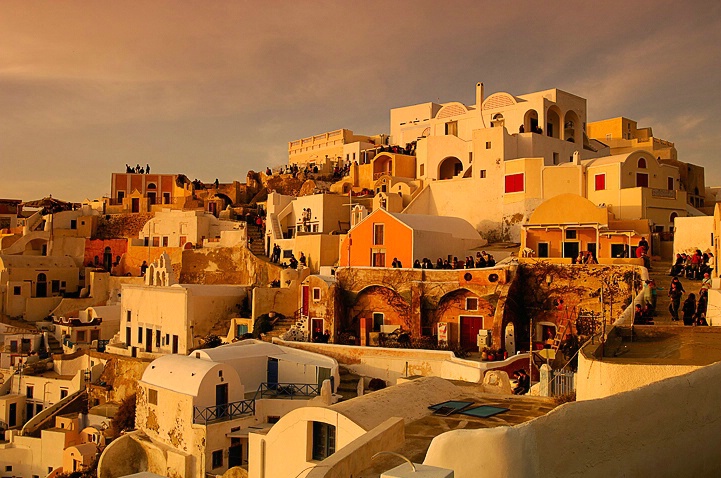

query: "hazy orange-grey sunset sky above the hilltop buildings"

left=0, top=0, right=721, bottom=201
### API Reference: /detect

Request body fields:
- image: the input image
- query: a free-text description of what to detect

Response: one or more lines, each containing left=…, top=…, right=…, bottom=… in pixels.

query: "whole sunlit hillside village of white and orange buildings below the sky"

left=0, top=83, right=721, bottom=478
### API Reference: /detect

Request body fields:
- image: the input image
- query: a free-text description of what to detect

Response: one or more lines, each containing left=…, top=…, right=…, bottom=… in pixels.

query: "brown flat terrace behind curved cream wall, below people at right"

left=596, top=325, right=721, bottom=366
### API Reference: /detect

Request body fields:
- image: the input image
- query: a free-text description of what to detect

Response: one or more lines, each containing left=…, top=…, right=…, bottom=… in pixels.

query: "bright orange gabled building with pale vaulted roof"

left=339, top=209, right=486, bottom=268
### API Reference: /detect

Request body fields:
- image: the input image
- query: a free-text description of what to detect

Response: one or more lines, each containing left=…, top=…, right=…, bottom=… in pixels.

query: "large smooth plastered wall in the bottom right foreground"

left=424, top=363, right=721, bottom=478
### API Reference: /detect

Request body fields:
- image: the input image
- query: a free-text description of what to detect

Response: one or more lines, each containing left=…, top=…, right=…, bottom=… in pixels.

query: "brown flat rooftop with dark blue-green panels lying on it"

left=354, top=380, right=557, bottom=478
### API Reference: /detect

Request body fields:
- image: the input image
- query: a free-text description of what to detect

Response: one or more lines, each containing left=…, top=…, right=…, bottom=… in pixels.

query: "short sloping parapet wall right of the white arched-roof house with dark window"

left=306, top=417, right=405, bottom=478
